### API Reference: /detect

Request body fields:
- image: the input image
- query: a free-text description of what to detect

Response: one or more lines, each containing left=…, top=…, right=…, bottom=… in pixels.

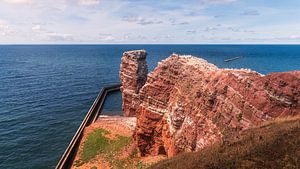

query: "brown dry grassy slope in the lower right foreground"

left=151, top=117, right=300, bottom=169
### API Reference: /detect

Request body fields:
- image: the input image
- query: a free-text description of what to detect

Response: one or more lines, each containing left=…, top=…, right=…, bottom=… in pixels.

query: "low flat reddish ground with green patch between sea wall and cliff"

left=72, top=117, right=151, bottom=169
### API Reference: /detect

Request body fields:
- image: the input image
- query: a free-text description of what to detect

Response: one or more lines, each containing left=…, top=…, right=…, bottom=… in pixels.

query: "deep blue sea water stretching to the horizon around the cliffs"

left=0, top=45, right=300, bottom=169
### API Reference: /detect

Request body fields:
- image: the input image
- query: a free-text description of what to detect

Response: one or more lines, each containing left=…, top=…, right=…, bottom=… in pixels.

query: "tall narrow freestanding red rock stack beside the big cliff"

left=120, top=50, right=148, bottom=117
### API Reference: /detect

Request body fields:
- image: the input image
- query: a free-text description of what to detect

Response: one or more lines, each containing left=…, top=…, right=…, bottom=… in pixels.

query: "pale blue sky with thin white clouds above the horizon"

left=0, top=0, right=300, bottom=44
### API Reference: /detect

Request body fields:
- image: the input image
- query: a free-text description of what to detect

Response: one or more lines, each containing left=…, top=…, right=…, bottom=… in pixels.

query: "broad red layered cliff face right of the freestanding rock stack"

left=123, top=50, right=300, bottom=156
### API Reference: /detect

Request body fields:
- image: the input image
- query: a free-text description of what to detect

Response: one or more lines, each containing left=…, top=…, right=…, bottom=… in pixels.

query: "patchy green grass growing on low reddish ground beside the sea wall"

left=75, top=128, right=146, bottom=169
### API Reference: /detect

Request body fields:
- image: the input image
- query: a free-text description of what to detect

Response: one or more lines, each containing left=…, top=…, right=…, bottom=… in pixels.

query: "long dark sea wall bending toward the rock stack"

left=55, top=84, right=121, bottom=169
